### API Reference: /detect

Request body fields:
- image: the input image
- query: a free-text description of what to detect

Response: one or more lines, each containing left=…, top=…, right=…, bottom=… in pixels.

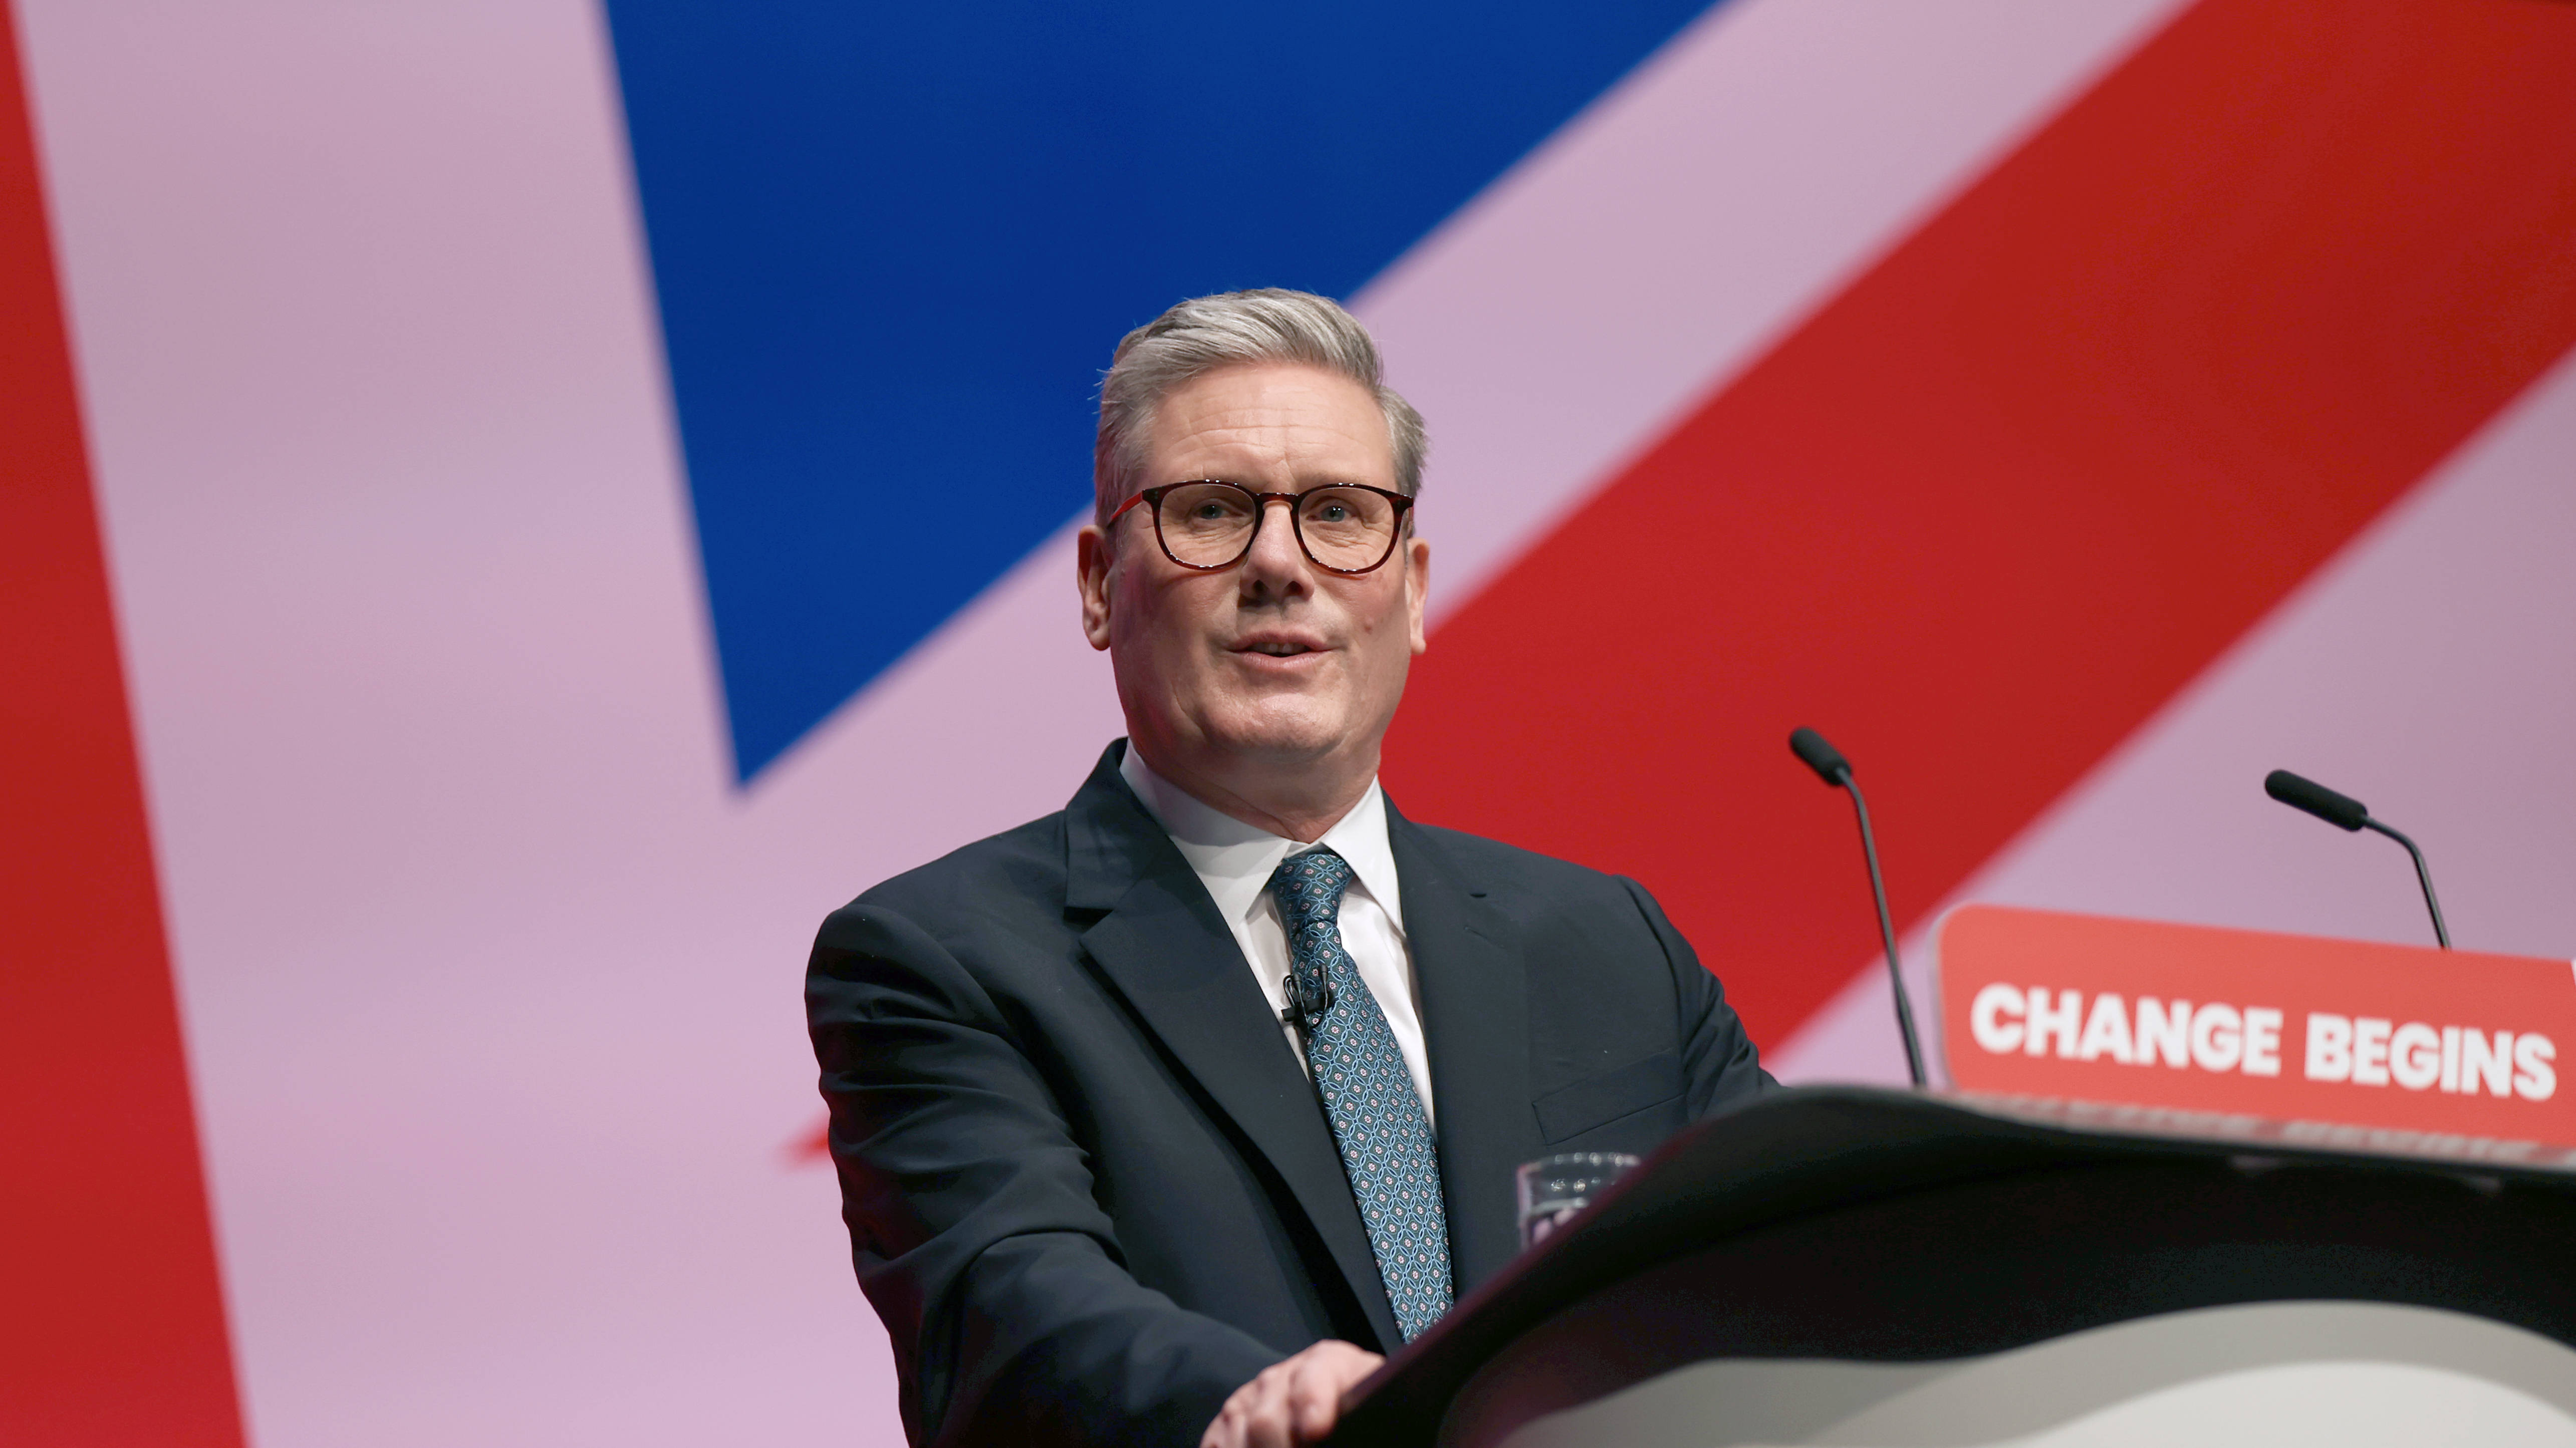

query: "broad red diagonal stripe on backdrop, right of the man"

left=1389, top=0, right=2576, bottom=1041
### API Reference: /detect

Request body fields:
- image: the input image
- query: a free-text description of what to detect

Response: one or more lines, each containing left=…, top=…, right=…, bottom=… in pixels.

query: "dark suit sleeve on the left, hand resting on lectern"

left=806, top=902, right=1280, bottom=1445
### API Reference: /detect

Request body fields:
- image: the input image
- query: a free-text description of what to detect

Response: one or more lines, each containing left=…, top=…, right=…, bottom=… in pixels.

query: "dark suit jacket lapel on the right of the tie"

left=1386, top=801, right=1545, bottom=1296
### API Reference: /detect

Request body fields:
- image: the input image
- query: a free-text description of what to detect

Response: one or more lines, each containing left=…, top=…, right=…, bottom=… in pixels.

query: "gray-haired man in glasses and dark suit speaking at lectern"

left=806, top=291, right=1770, bottom=1448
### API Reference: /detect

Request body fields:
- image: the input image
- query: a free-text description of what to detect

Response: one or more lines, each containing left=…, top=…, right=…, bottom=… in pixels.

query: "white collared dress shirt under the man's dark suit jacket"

left=1118, top=745, right=1432, bottom=1118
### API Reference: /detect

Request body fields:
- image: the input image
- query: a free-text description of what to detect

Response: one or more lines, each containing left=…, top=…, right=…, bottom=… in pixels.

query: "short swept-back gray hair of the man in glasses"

left=1092, top=286, right=1430, bottom=525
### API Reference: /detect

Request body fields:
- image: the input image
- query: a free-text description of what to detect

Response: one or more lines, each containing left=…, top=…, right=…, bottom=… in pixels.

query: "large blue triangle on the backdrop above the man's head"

left=608, top=0, right=1708, bottom=781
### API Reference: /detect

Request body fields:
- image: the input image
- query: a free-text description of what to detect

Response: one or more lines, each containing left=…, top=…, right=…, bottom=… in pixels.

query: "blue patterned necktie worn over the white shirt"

left=1270, top=850, right=1453, bottom=1342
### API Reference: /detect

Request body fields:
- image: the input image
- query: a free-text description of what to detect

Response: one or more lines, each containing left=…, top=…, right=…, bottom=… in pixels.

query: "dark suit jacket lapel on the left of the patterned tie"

left=1067, top=745, right=1401, bottom=1345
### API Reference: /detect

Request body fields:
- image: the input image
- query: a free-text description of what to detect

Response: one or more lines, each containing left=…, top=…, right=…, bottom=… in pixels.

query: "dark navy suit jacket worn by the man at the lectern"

left=806, top=742, right=1770, bottom=1445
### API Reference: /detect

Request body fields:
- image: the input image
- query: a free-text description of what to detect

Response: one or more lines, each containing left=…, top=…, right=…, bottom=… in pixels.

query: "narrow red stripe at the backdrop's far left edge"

left=0, top=8, right=242, bottom=1448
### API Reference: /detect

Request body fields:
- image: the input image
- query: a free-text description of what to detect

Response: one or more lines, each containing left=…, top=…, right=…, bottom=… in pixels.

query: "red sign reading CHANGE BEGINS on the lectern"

left=1935, top=905, right=2576, bottom=1160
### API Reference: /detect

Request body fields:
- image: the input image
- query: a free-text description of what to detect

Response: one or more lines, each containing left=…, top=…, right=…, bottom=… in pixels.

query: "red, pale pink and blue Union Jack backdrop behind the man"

left=0, top=0, right=2576, bottom=1448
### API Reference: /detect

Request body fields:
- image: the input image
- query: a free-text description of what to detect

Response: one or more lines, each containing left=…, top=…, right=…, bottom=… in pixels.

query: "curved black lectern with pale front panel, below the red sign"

left=1332, top=1087, right=2576, bottom=1448
